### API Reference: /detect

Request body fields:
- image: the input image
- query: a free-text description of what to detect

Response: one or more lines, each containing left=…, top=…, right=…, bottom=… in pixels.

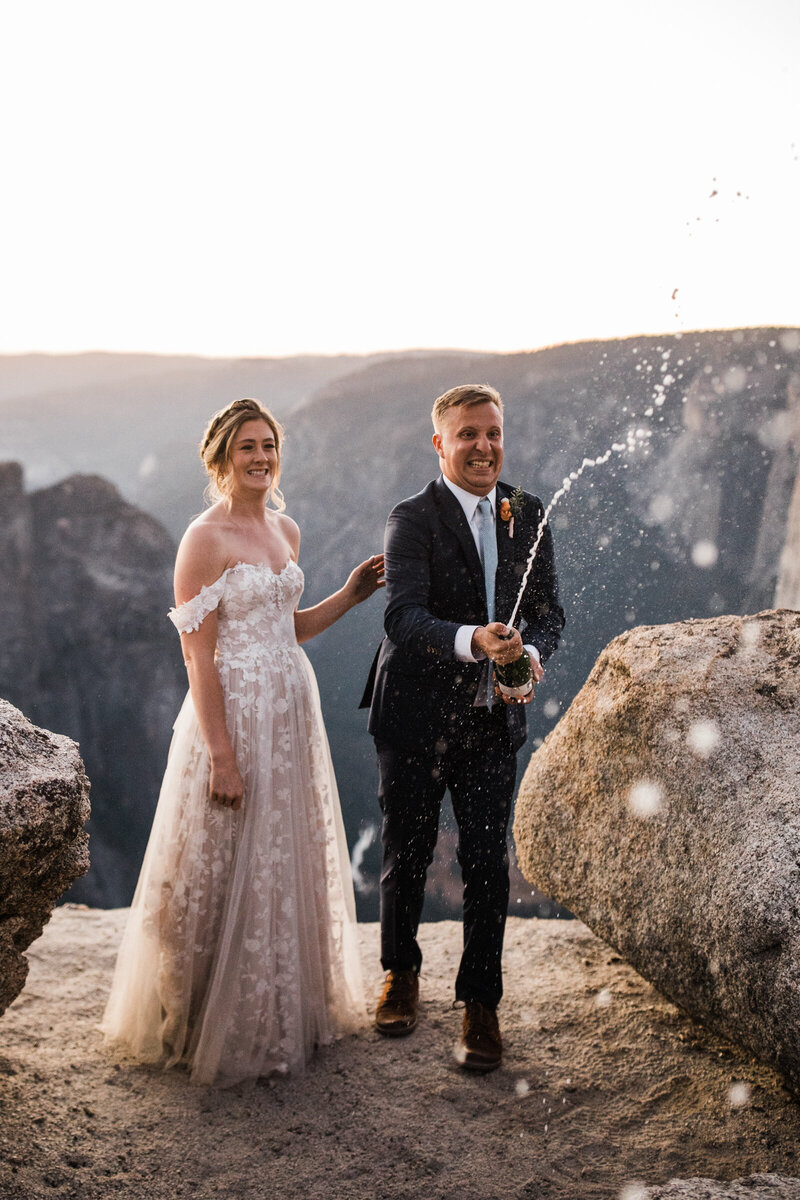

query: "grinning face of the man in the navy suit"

left=433, top=402, right=503, bottom=496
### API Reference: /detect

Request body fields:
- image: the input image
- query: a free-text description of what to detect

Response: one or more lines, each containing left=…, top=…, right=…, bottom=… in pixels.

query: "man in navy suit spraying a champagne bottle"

left=362, top=384, right=564, bottom=1070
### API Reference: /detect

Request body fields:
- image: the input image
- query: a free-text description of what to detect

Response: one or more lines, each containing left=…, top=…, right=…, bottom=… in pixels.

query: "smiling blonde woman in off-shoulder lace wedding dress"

left=102, top=400, right=383, bottom=1086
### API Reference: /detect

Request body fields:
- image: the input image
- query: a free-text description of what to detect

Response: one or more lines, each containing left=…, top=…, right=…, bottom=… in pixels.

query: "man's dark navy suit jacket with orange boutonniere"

left=361, top=476, right=564, bottom=752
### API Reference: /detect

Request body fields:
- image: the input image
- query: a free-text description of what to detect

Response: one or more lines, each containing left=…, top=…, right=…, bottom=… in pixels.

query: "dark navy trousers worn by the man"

left=375, top=709, right=517, bottom=1008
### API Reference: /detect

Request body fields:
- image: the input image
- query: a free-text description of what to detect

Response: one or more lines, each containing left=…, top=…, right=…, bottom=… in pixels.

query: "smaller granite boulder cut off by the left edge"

left=0, top=700, right=89, bottom=1013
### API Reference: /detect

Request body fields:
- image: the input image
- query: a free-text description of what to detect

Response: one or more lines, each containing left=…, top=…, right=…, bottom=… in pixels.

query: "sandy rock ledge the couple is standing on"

left=0, top=907, right=800, bottom=1200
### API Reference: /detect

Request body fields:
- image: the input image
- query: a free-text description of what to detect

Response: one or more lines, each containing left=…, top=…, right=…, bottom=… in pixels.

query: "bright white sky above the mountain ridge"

left=0, top=0, right=800, bottom=355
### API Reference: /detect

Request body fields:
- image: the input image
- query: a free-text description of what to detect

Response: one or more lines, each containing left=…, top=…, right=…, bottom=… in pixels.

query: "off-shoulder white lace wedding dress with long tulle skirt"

left=102, top=560, right=365, bottom=1086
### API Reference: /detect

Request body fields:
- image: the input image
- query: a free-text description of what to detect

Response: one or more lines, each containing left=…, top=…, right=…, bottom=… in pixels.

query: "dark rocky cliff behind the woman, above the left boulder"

left=0, top=463, right=185, bottom=905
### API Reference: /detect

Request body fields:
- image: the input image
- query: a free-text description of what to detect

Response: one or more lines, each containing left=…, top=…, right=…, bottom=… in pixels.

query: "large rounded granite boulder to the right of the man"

left=515, top=611, right=800, bottom=1090
